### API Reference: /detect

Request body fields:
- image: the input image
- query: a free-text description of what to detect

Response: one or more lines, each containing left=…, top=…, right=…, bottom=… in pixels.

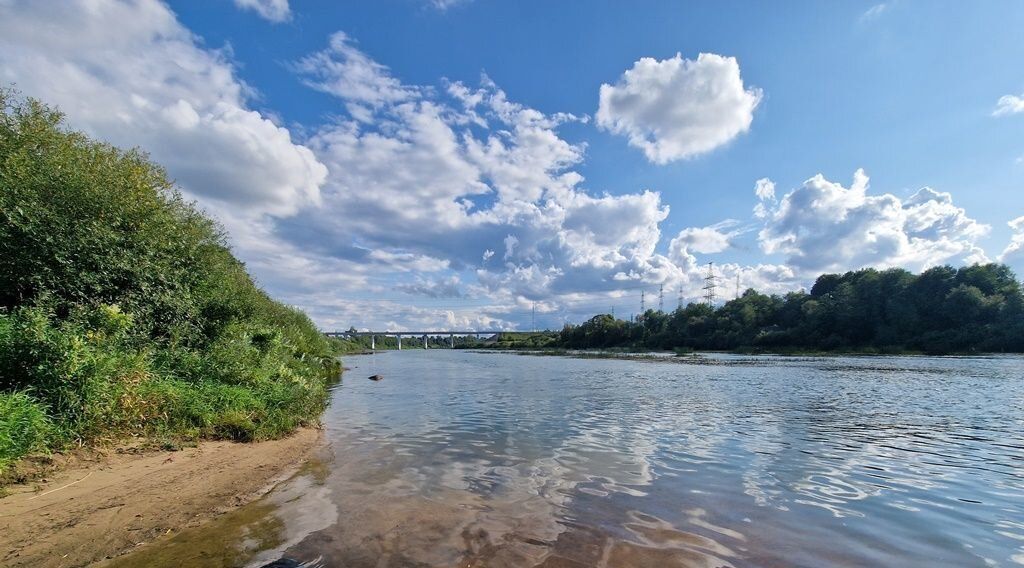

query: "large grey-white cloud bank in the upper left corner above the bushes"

left=0, top=0, right=327, bottom=215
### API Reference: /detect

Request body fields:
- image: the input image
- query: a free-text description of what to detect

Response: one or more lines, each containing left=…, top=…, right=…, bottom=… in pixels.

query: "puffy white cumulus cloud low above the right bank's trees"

left=759, top=170, right=989, bottom=272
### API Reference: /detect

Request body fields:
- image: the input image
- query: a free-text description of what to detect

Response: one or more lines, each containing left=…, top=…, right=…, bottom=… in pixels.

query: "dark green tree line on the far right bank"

left=558, top=264, right=1024, bottom=354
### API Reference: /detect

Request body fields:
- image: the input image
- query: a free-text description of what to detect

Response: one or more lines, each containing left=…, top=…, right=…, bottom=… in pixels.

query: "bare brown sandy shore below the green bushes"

left=0, top=429, right=321, bottom=568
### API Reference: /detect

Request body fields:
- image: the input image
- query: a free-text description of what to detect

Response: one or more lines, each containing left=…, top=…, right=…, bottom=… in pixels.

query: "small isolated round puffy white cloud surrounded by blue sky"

left=597, top=53, right=762, bottom=164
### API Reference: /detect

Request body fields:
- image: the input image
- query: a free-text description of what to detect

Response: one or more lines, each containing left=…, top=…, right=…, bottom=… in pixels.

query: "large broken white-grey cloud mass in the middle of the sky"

left=268, top=34, right=682, bottom=327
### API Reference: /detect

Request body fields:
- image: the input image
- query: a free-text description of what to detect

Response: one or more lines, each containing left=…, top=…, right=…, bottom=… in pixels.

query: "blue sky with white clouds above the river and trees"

left=0, top=0, right=1024, bottom=331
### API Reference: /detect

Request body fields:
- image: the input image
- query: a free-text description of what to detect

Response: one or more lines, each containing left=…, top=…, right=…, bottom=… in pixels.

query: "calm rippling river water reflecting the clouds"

left=116, top=350, right=1024, bottom=567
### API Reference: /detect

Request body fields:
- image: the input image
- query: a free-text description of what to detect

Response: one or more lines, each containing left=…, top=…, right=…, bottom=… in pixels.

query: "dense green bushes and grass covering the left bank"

left=0, top=91, right=339, bottom=470
